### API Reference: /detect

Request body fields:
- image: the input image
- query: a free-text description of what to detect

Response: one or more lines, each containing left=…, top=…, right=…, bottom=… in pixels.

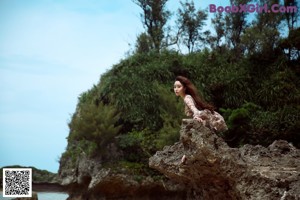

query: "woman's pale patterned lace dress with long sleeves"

left=184, top=95, right=228, bottom=132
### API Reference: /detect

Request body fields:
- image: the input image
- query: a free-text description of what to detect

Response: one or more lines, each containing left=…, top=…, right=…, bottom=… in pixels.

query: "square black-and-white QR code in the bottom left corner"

left=3, top=168, right=32, bottom=197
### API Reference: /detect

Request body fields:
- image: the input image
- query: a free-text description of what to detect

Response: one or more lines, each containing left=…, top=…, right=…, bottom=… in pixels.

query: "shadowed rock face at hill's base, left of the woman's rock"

left=59, top=146, right=185, bottom=200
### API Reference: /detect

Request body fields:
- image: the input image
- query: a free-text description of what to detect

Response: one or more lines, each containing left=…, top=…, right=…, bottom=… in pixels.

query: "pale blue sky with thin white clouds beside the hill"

left=0, top=0, right=230, bottom=172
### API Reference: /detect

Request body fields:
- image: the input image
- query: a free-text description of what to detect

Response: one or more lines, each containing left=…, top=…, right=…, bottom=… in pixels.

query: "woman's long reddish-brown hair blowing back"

left=175, top=76, right=215, bottom=112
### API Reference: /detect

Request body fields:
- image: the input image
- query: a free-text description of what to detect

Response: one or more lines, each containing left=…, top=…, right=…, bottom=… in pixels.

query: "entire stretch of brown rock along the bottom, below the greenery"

left=59, top=119, right=300, bottom=200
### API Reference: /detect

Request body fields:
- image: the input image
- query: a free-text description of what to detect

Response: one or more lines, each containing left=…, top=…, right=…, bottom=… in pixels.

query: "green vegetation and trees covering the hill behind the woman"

left=61, top=0, right=300, bottom=179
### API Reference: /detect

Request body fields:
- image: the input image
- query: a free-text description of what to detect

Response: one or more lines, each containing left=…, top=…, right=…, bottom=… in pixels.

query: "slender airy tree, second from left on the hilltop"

left=177, top=0, right=207, bottom=53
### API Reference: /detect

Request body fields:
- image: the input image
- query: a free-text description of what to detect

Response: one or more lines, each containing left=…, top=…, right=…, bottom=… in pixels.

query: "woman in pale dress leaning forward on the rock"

left=174, top=76, right=227, bottom=163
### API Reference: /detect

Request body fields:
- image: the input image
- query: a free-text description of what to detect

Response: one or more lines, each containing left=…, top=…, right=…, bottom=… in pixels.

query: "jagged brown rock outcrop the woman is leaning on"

left=149, top=119, right=300, bottom=200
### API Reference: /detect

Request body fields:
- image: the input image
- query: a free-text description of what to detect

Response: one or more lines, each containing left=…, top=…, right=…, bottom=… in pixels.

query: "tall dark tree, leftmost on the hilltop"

left=132, top=0, right=170, bottom=52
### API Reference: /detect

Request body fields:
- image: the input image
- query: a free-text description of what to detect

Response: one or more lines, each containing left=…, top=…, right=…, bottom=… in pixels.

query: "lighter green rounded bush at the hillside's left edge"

left=62, top=101, right=121, bottom=161
